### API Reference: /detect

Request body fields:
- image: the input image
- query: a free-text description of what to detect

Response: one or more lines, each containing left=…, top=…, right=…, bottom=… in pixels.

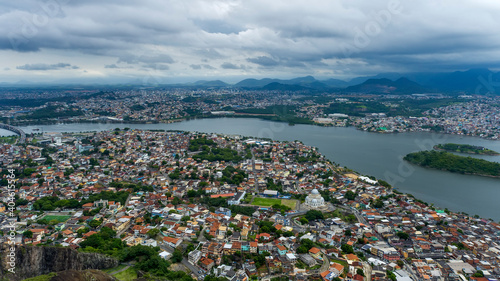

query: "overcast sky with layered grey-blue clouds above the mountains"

left=0, top=0, right=500, bottom=83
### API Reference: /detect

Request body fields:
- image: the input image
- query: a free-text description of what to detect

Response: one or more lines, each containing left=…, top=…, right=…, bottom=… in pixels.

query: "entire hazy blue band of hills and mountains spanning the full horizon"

left=0, top=68, right=500, bottom=95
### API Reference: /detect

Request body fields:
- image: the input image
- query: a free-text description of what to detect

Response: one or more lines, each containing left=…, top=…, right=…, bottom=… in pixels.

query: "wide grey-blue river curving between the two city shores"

left=0, top=118, right=500, bottom=221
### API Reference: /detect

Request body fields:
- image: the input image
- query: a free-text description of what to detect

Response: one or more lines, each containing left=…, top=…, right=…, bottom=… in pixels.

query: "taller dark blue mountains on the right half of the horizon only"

left=233, top=68, right=500, bottom=95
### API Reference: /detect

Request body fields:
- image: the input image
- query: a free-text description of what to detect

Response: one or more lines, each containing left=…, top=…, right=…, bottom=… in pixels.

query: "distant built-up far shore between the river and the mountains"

left=0, top=87, right=500, bottom=140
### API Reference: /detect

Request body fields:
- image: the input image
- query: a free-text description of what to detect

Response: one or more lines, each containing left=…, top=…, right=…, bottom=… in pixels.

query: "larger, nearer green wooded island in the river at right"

left=403, top=150, right=500, bottom=177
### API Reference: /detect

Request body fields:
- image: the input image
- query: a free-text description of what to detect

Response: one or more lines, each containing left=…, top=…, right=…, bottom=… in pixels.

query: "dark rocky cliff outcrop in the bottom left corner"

left=0, top=246, right=119, bottom=281
